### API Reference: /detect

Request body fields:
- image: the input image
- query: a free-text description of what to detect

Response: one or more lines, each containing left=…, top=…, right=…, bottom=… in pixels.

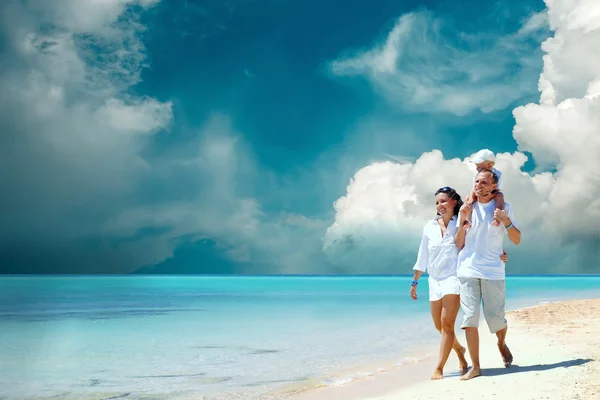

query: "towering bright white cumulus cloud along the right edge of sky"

left=514, top=0, right=600, bottom=241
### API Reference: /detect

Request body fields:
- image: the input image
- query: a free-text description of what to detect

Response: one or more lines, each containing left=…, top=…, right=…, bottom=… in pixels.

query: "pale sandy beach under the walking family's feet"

left=291, top=299, right=600, bottom=400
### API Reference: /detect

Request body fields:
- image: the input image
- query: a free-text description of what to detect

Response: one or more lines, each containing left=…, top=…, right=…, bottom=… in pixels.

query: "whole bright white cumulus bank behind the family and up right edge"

left=323, top=0, right=600, bottom=273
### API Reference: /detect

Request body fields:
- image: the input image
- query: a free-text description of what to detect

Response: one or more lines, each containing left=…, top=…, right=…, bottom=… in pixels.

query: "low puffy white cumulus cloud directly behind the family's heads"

left=323, top=150, right=551, bottom=273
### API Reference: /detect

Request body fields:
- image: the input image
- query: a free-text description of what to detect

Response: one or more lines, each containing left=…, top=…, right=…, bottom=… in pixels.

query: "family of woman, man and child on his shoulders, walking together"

left=410, top=150, right=521, bottom=380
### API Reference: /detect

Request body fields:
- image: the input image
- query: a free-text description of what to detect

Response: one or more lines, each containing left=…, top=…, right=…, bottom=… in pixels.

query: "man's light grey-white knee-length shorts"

left=460, top=278, right=507, bottom=333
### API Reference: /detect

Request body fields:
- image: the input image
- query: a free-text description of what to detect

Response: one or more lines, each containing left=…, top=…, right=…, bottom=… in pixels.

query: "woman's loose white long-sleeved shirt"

left=413, top=216, right=458, bottom=280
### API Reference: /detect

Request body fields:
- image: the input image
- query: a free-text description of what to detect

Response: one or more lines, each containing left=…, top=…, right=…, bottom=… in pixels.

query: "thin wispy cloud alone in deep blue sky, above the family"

left=329, top=11, right=547, bottom=116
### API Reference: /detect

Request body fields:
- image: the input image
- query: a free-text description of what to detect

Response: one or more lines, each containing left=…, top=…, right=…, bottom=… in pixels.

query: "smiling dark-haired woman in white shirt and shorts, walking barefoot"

left=410, top=186, right=508, bottom=379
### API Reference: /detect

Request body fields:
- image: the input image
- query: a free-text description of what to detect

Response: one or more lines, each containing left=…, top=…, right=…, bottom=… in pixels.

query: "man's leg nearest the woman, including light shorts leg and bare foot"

left=460, top=278, right=481, bottom=380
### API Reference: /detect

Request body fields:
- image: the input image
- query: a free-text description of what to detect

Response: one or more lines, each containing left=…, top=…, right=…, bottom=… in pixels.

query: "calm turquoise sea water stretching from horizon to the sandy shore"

left=0, top=276, right=600, bottom=399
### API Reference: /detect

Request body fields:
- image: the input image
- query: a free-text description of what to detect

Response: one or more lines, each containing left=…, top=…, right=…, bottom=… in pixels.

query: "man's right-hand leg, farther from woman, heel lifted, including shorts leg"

left=481, top=279, right=513, bottom=368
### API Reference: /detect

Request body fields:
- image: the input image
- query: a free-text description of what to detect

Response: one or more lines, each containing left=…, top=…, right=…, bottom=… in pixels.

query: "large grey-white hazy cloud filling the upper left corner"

left=0, top=0, right=172, bottom=241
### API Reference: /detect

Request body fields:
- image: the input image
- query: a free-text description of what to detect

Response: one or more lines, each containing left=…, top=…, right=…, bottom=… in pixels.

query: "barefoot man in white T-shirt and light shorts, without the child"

left=455, top=170, right=521, bottom=380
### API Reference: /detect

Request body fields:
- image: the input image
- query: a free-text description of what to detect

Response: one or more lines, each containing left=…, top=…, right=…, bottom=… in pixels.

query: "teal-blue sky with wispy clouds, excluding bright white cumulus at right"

left=0, top=0, right=587, bottom=273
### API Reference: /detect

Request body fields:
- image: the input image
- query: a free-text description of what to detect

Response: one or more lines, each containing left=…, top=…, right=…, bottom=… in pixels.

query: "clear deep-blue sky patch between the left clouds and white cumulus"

left=137, top=1, right=543, bottom=214
